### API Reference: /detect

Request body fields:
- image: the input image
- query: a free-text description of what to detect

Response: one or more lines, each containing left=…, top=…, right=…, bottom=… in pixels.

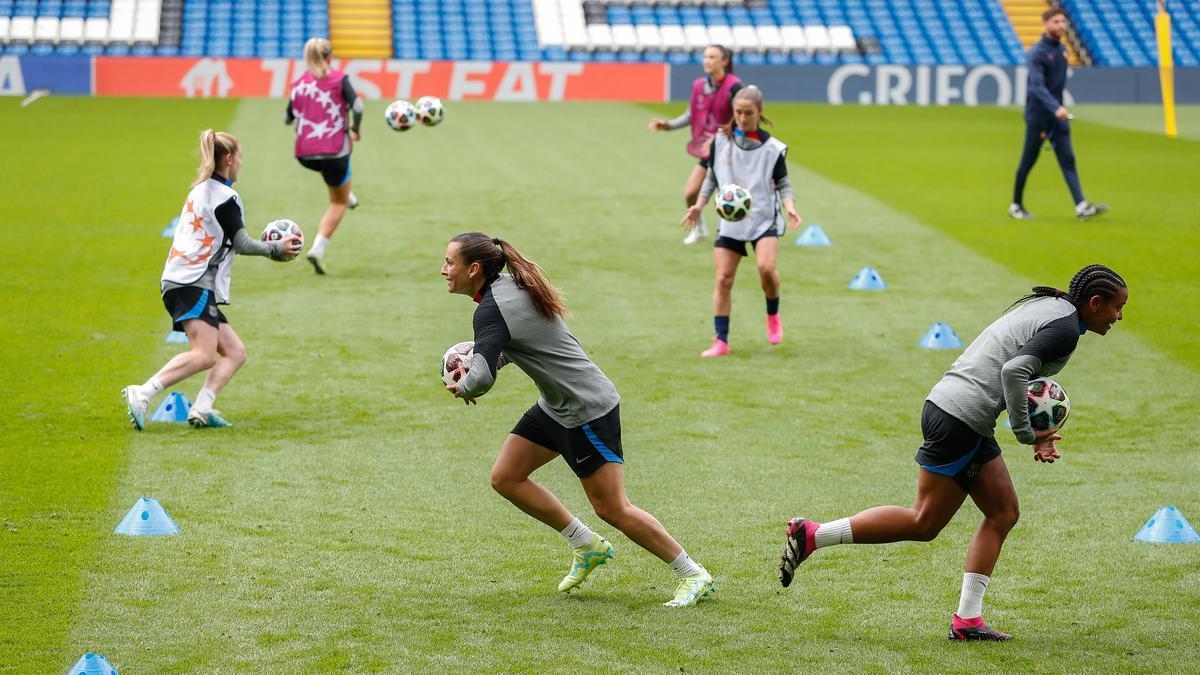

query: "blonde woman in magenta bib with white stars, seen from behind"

left=283, top=37, right=362, bottom=274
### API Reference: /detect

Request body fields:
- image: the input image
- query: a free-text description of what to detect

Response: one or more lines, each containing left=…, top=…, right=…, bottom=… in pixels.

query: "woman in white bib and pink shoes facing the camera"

left=683, top=84, right=800, bottom=357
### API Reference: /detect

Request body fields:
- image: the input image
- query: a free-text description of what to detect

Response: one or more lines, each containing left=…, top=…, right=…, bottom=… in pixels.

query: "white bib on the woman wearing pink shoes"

left=713, top=133, right=787, bottom=241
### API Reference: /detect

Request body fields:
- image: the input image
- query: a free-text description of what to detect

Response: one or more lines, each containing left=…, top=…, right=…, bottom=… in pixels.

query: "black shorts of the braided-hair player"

left=917, top=401, right=1000, bottom=492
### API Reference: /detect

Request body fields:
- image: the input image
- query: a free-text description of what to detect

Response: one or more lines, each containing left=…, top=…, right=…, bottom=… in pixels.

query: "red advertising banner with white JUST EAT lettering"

left=94, top=56, right=670, bottom=101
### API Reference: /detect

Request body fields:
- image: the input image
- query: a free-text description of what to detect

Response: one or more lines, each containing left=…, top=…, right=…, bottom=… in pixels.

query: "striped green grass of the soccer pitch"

left=0, top=98, right=1200, bottom=673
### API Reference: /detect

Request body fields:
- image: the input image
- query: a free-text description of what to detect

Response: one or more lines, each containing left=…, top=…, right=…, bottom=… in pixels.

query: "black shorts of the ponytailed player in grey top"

left=512, top=404, right=625, bottom=478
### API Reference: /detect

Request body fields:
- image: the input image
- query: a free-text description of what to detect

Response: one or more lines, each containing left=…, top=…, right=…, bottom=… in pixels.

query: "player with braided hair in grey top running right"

left=779, top=264, right=1129, bottom=640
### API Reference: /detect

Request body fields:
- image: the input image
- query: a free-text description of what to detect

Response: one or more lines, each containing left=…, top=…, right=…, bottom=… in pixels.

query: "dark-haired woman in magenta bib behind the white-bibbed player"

left=647, top=44, right=742, bottom=244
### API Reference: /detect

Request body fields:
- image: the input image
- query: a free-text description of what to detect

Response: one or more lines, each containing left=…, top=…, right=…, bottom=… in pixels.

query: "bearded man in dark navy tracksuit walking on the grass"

left=1008, top=7, right=1109, bottom=220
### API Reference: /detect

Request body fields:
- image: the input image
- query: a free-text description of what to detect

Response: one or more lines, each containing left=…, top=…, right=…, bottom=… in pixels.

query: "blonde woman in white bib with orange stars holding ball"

left=121, top=129, right=301, bottom=431
